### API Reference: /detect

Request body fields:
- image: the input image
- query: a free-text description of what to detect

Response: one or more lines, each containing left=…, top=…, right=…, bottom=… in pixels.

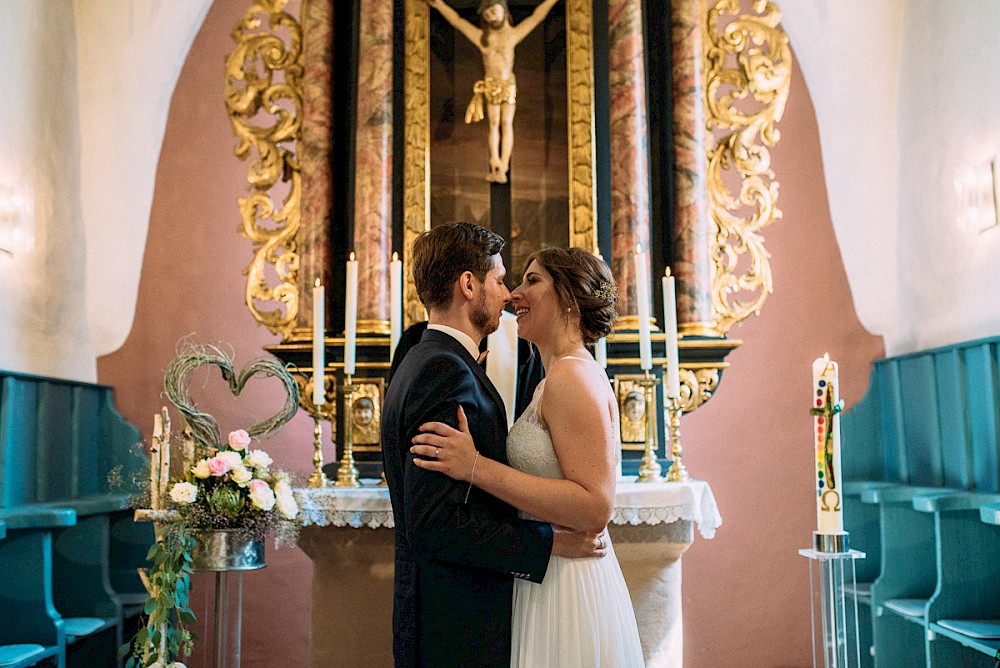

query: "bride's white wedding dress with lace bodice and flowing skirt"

left=507, top=358, right=643, bottom=668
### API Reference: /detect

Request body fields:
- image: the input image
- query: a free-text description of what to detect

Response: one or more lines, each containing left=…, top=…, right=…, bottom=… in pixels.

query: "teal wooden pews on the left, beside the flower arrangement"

left=0, top=371, right=153, bottom=667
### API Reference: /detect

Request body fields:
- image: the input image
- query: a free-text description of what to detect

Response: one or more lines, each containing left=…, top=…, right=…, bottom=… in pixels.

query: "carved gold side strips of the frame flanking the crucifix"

left=403, top=0, right=598, bottom=327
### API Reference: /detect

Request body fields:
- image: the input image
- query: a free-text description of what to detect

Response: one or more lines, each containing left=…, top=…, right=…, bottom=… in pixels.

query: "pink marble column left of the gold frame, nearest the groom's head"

left=353, top=0, right=393, bottom=332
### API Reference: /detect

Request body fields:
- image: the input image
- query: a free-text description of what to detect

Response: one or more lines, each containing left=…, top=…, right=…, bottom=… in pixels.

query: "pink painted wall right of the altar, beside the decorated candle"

left=682, top=54, right=884, bottom=668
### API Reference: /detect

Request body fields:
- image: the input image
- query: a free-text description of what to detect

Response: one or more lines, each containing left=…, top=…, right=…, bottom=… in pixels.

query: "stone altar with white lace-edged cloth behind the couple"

left=295, top=478, right=722, bottom=668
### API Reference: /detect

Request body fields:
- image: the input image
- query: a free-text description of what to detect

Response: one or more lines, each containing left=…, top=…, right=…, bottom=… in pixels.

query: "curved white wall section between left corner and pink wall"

left=74, top=0, right=213, bottom=356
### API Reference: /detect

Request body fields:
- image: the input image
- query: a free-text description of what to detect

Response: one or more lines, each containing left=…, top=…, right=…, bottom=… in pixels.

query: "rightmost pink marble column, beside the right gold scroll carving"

left=670, top=0, right=714, bottom=334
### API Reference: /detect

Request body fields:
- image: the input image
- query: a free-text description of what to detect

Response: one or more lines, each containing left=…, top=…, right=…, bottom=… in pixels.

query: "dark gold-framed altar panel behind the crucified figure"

left=397, top=0, right=597, bottom=326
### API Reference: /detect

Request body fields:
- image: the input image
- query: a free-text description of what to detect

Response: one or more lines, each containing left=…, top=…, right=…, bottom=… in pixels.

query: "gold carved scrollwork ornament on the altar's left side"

left=225, top=0, right=303, bottom=338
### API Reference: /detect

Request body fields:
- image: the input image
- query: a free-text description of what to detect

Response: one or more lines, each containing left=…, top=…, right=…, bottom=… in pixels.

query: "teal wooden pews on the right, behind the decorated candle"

left=841, top=337, right=1000, bottom=668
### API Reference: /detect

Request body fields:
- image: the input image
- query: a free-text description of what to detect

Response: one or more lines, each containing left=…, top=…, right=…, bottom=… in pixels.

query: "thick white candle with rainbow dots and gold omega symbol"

left=812, top=354, right=844, bottom=535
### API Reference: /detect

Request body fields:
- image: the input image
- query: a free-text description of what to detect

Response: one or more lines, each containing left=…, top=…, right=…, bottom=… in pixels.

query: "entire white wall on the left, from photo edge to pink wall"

left=0, top=0, right=208, bottom=381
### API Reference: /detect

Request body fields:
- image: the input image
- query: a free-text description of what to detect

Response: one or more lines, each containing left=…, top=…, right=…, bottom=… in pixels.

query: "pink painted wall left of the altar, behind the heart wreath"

left=97, top=0, right=312, bottom=666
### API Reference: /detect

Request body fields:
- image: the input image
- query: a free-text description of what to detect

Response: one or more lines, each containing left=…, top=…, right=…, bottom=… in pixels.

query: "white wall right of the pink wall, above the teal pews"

left=780, top=0, right=1000, bottom=355
